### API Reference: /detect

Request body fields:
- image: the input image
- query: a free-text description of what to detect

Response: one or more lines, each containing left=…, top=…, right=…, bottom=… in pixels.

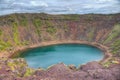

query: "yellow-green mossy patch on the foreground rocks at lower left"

left=7, top=59, right=34, bottom=77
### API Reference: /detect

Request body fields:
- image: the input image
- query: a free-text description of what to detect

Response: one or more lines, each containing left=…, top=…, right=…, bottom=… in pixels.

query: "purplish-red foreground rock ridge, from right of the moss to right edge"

left=32, top=62, right=120, bottom=80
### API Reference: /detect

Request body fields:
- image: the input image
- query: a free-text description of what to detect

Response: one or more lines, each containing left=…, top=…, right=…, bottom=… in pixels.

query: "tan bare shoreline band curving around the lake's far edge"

left=0, top=40, right=112, bottom=62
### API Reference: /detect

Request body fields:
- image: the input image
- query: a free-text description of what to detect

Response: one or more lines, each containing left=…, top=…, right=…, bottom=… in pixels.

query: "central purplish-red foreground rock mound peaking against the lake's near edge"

left=35, top=63, right=72, bottom=80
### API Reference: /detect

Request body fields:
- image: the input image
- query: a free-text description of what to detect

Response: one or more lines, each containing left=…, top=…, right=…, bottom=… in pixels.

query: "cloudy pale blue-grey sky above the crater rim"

left=0, top=0, right=120, bottom=15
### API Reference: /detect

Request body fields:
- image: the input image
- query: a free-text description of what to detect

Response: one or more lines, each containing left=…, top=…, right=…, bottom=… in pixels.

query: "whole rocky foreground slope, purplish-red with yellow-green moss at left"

left=0, top=58, right=120, bottom=80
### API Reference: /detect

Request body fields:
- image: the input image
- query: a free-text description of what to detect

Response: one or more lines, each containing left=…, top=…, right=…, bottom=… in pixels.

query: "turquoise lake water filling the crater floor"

left=20, top=44, right=104, bottom=68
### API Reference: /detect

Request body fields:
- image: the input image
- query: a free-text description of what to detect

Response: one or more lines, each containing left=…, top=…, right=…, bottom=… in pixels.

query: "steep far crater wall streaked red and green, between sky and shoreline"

left=0, top=14, right=120, bottom=56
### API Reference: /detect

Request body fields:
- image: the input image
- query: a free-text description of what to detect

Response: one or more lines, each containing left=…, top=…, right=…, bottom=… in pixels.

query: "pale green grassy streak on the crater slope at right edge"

left=104, top=24, right=120, bottom=43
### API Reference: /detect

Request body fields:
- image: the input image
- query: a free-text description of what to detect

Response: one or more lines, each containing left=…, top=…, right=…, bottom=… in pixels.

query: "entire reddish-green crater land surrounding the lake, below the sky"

left=0, top=13, right=120, bottom=80
